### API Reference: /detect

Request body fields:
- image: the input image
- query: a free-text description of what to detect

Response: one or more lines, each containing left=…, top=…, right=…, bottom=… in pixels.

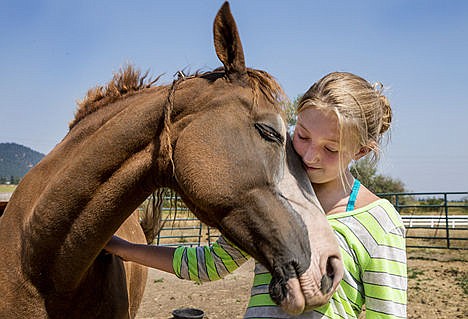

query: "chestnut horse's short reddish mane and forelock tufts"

left=69, top=64, right=286, bottom=129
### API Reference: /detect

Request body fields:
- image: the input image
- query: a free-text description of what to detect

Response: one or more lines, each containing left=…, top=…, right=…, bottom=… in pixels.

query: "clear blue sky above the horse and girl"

left=0, top=0, right=468, bottom=192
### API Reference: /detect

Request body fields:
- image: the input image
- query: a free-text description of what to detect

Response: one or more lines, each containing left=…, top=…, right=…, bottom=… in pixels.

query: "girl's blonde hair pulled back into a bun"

left=297, top=72, right=392, bottom=184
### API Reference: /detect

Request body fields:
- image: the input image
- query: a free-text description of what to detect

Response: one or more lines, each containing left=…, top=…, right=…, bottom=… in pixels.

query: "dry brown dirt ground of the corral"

left=137, top=249, right=468, bottom=319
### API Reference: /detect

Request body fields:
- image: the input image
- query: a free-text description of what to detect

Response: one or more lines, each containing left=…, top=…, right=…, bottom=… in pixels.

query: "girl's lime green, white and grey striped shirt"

left=174, top=199, right=407, bottom=319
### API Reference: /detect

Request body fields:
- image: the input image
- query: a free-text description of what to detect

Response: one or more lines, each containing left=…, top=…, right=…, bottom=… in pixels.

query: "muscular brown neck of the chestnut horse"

left=19, top=87, right=174, bottom=290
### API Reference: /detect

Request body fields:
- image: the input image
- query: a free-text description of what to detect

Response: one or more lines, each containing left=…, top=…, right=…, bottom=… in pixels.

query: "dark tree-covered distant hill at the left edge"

left=0, top=143, right=44, bottom=183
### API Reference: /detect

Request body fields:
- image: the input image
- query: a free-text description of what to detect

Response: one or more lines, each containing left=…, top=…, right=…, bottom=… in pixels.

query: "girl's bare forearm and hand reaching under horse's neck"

left=104, top=236, right=176, bottom=274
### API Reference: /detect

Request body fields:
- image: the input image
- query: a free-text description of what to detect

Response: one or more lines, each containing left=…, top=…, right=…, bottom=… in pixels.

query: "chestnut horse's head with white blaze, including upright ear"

left=173, top=3, right=343, bottom=313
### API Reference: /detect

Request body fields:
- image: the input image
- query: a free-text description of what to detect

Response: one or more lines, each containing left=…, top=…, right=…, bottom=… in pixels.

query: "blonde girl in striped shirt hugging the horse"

left=106, top=72, right=407, bottom=318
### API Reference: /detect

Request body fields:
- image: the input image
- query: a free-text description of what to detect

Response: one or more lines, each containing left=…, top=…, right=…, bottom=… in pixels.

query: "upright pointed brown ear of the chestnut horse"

left=213, top=1, right=247, bottom=81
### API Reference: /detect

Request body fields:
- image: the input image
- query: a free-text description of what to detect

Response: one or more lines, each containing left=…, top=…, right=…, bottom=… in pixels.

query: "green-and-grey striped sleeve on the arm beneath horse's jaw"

left=173, top=236, right=249, bottom=282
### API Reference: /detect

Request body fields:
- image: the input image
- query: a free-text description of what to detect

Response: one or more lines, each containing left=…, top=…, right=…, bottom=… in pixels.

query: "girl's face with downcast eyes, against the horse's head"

left=293, top=107, right=351, bottom=184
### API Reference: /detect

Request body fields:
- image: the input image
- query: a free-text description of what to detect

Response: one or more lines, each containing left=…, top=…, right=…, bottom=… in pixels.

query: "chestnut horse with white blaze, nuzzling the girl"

left=0, top=3, right=342, bottom=319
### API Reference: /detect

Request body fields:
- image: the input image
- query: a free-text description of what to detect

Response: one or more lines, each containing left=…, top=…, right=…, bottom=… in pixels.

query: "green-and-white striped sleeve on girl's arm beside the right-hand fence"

left=362, top=227, right=407, bottom=319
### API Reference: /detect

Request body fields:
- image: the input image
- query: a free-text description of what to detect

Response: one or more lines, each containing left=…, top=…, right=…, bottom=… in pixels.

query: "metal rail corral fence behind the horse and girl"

left=154, top=192, right=468, bottom=249
